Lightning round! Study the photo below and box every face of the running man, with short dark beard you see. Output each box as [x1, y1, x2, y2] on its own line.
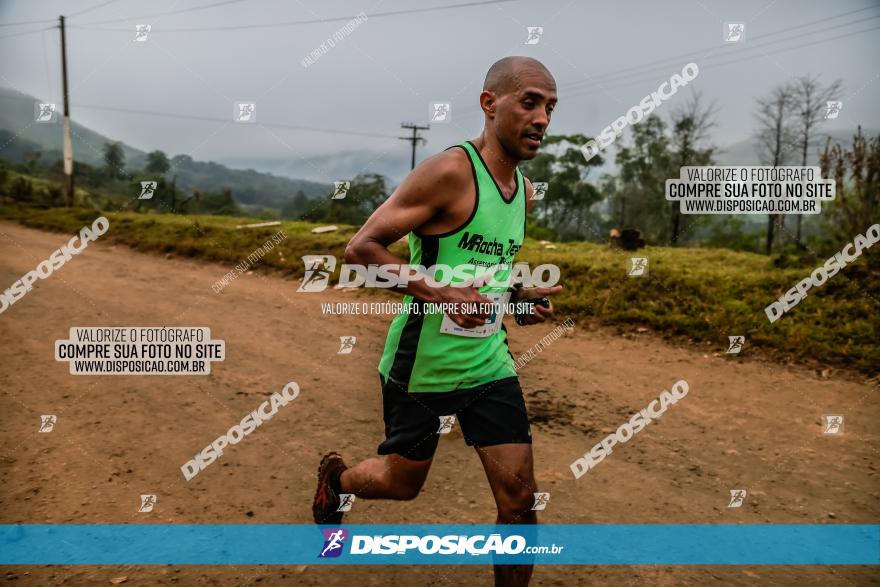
[494, 67, 556, 161]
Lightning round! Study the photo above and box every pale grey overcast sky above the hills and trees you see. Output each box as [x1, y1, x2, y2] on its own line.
[0, 0, 880, 183]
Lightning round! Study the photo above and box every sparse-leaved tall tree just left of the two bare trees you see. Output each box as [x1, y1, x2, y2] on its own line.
[664, 92, 717, 246]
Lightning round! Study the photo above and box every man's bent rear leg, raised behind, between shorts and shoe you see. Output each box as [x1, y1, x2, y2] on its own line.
[340, 454, 434, 500]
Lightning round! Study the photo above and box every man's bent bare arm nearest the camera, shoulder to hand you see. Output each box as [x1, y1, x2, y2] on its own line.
[345, 149, 488, 328]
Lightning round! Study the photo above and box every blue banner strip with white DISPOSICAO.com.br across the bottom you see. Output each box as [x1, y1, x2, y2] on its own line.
[0, 524, 880, 565]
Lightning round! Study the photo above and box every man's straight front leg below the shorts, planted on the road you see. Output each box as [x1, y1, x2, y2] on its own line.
[477, 444, 538, 587]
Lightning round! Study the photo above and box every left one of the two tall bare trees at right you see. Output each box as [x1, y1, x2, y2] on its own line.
[755, 84, 795, 255]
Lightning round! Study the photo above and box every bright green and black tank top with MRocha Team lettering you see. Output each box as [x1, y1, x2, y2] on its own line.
[379, 141, 526, 392]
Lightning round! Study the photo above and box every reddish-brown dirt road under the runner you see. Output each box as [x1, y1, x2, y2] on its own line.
[0, 222, 880, 586]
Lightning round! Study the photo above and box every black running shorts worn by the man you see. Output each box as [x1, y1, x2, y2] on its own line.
[378, 375, 532, 461]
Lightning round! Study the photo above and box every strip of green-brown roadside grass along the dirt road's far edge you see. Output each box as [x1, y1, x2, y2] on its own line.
[0, 206, 880, 374]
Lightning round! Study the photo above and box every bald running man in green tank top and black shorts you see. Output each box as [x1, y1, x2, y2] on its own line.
[312, 57, 562, 585]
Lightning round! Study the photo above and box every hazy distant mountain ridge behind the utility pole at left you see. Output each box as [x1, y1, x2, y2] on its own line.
[0, 88, 332, 210]
